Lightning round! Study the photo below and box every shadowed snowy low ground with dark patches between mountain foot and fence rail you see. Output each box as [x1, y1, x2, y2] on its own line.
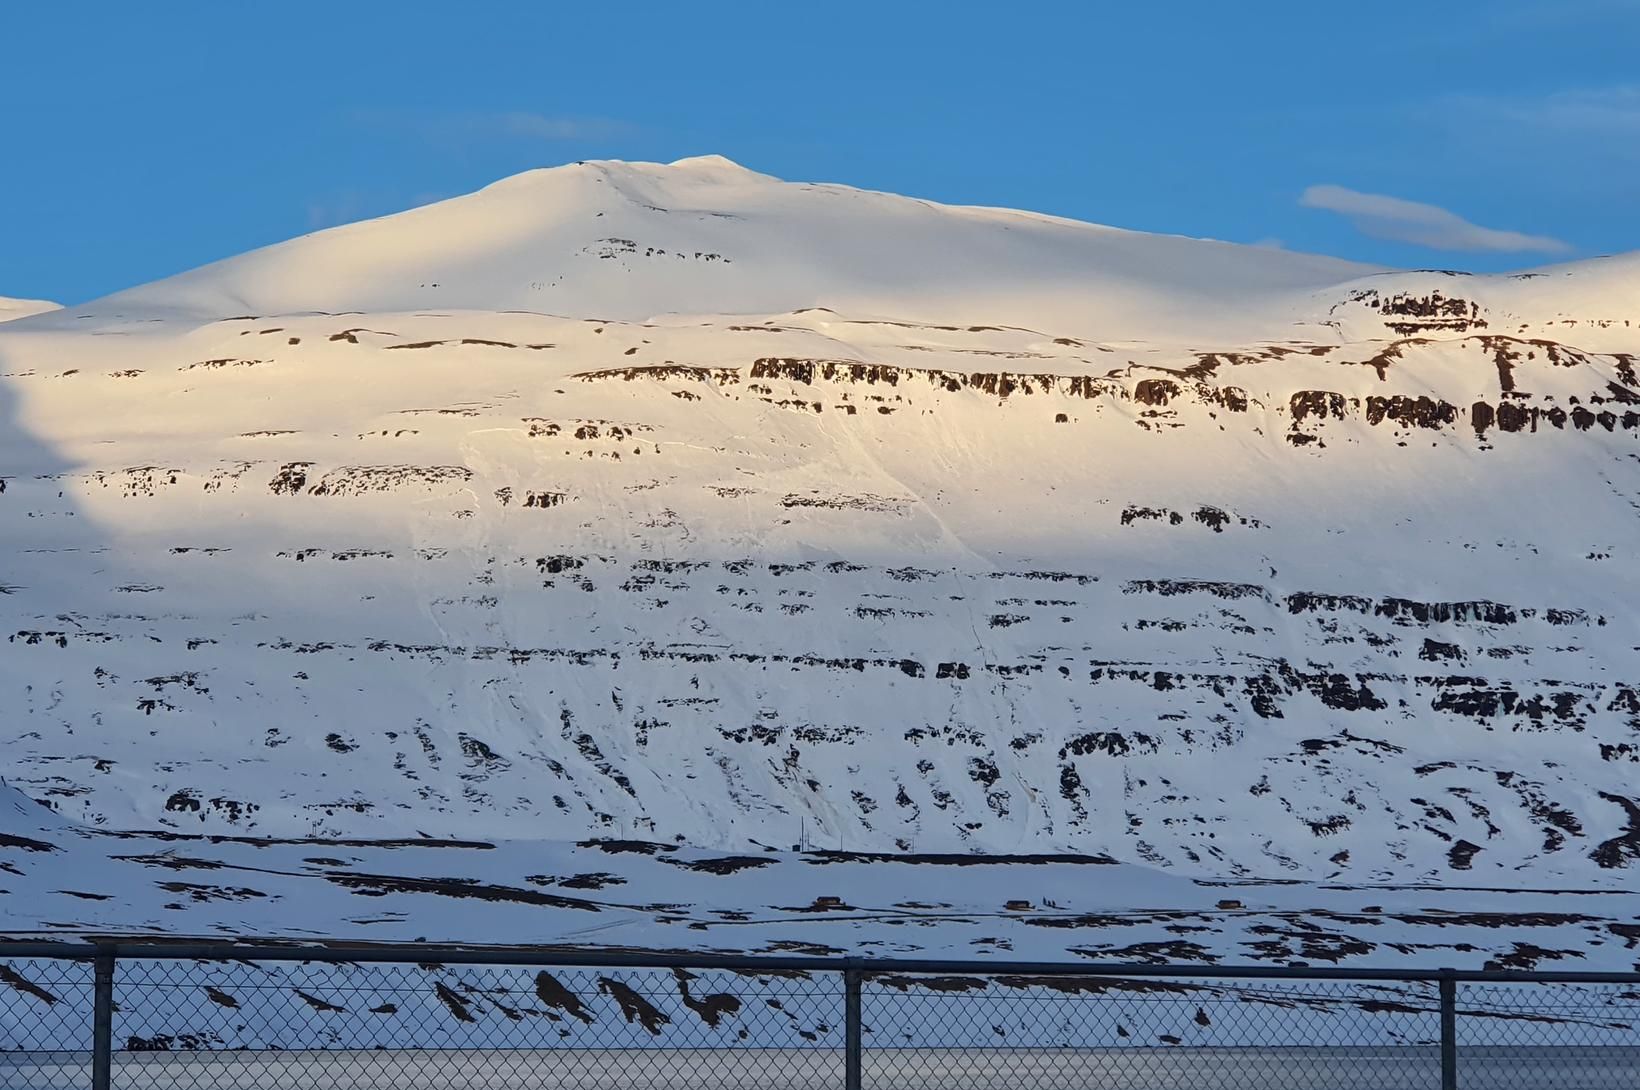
[0, 788, 1640, 970]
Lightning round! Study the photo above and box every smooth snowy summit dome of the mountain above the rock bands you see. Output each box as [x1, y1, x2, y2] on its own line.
[35, 156, 1374, 339]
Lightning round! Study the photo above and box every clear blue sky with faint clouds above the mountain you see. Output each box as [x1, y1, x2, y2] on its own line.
[0, 0, 1640, 302]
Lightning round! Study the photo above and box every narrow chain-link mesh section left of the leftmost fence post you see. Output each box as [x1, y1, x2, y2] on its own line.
[0, 959, 93, 1090]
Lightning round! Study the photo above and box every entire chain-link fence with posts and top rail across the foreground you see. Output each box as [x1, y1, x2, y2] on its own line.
[0, 942, 1640, 1090]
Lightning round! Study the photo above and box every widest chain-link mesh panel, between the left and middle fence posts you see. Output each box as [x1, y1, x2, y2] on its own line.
[113, 962, 843, 1090]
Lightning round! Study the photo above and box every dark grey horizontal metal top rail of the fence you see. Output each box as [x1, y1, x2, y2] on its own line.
[0, 938, 1640, 987]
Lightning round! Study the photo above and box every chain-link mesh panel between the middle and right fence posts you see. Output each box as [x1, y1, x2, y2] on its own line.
[861, 975, 1440, 1090]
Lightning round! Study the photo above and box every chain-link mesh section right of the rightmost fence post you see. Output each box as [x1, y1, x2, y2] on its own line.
[1458, 983, 1640, 1090]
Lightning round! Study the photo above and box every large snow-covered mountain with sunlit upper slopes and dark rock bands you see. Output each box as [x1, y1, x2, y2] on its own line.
[0, 157, 1640, 929]
